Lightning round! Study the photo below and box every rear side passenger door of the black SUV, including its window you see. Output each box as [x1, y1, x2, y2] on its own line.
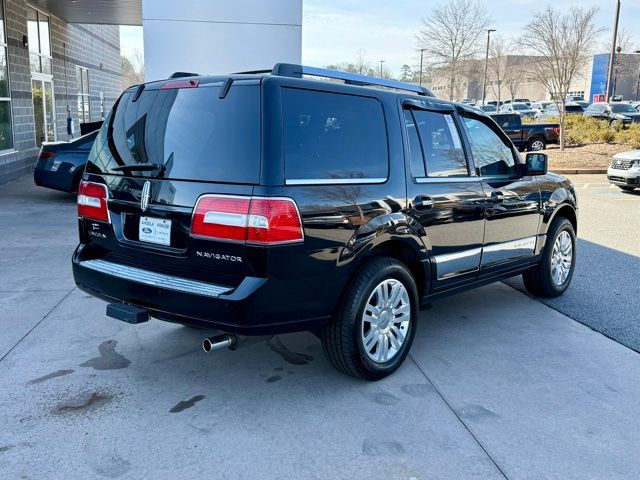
[403, 105, 484, 290]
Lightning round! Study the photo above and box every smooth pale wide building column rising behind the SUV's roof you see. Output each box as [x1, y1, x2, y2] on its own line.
[142, 0, 302, 81]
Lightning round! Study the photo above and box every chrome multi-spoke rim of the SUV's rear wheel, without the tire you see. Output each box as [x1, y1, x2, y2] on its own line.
[361, 278, 411, 363]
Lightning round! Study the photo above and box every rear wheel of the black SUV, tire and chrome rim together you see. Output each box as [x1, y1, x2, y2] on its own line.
[321, 257, 418, 380]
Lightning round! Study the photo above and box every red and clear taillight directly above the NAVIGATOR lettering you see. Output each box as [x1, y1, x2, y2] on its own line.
[191, 195, 304, 245]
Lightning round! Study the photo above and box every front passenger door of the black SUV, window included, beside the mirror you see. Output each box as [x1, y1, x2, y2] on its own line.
[463, 113, 541, 275]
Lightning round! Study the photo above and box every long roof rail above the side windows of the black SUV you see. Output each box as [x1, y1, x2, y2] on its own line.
[271, 63, 435, 97]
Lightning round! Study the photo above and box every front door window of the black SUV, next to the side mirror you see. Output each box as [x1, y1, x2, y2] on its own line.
[464, 117, 517, 176]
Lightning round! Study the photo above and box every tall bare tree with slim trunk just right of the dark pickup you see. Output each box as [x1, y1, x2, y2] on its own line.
[518, 6, 601, 150]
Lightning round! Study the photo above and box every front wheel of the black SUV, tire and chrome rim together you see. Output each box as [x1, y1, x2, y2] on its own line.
[522, 217, 576, 298]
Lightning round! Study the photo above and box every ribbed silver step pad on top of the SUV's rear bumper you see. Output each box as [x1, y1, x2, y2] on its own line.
[79, 260, 232, 298]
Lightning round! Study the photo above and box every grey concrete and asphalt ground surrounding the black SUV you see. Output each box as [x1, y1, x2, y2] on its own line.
[0, 175, 640, 479]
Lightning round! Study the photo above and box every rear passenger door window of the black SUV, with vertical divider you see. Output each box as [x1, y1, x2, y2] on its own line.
[413, 110, 469, 177]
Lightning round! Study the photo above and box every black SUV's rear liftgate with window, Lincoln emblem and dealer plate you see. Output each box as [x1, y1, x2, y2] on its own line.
[85, 80, 261, 286]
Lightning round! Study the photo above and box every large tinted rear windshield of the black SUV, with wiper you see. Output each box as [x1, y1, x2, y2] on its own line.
[87, 85, 260, 183]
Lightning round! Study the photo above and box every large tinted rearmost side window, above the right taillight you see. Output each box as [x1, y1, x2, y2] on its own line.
[282, 88, 389, 180]
